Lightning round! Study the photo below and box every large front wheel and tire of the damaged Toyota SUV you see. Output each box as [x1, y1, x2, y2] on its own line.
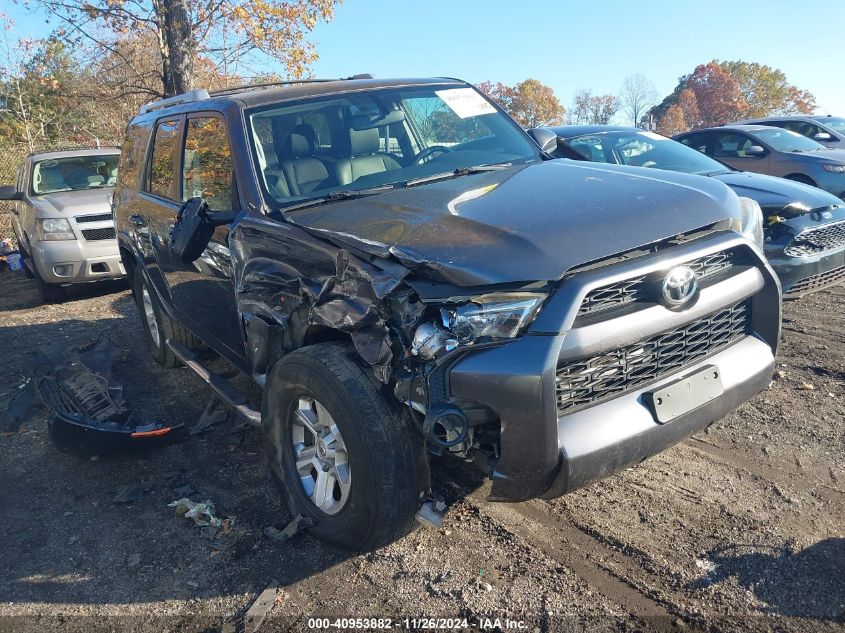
[262, 342, 427, 551]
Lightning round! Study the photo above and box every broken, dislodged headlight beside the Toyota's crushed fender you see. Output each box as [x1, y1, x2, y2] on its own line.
[411, 292, 546, 360]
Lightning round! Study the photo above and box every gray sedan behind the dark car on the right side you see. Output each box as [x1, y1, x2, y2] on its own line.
[673, 125, 845, 200]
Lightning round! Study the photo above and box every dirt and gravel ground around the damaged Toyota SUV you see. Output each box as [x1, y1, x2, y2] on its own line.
[0, 273, 845, 632]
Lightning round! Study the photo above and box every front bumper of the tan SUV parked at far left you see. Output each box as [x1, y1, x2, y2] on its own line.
[30, 240, 126, 284]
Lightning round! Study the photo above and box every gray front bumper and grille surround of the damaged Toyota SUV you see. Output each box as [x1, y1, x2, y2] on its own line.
[447, 236, 780, 501]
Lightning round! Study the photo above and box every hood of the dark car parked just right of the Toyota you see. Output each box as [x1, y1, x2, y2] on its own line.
[713, 170, 845, 217]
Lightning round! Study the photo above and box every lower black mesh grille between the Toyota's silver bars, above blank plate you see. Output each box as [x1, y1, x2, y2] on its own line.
[557, 301, 751, 415]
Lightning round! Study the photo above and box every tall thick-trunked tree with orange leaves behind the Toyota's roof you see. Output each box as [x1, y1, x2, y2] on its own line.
[32, 0, 338, 96]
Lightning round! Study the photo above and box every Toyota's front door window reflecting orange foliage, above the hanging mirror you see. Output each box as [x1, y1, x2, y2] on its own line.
[182, 117, 235, 211]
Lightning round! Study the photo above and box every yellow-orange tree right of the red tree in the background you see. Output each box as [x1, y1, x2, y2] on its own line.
[719, 61, 816, 118]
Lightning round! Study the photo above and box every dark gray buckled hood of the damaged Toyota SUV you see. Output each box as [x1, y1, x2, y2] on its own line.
[288, 160, 739, 286]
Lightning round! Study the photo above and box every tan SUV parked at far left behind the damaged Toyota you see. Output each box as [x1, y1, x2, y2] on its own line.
[0, 148, 126, 302]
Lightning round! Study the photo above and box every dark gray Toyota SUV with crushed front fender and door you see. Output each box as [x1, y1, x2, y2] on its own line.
[114, 76, 781, 550]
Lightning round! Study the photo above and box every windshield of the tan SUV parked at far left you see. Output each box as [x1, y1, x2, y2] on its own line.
[32, 154, 118, 195]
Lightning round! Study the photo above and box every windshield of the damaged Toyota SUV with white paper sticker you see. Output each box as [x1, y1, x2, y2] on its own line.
[248, 86, 540, 207]
